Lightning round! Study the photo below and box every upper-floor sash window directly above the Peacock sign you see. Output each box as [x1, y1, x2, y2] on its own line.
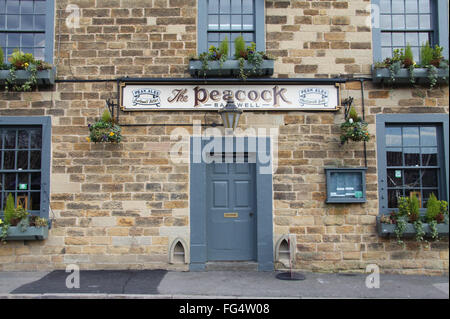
[198, 0, 265, 56]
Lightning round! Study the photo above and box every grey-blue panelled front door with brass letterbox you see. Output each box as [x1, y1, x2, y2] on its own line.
[206, 163, 256, 261]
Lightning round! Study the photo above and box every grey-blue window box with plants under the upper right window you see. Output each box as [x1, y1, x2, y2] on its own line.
[372, 43, 449, 88]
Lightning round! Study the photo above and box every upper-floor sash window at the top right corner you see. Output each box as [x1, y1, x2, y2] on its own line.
[372, 0, 448, 62]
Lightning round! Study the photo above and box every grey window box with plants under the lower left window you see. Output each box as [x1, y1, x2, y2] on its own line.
[0, 194, 49, 243]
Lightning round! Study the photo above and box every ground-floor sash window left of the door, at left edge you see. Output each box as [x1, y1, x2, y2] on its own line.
[0, 117, 51, 218]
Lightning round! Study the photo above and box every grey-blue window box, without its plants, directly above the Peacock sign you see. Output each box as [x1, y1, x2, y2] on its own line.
[189, 60, 274, 78]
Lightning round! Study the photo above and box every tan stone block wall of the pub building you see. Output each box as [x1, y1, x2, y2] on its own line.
[0, 0, 449, 274]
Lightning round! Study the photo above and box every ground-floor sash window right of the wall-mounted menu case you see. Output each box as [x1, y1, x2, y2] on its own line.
[377, 114, 448, 213]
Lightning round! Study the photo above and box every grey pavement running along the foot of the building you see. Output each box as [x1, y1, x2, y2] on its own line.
[0, 270, 449, 299]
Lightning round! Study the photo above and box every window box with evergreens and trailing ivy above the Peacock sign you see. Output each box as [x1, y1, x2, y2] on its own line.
[189, 36, 274, 80]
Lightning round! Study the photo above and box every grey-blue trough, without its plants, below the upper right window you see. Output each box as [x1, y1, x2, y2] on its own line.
[372, 67, 448, 84]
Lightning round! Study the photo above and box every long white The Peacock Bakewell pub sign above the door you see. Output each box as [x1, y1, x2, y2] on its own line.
[120, 81, 340, 111]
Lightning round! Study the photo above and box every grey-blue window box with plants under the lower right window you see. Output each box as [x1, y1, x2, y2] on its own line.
[377, 194, 448, 241]
